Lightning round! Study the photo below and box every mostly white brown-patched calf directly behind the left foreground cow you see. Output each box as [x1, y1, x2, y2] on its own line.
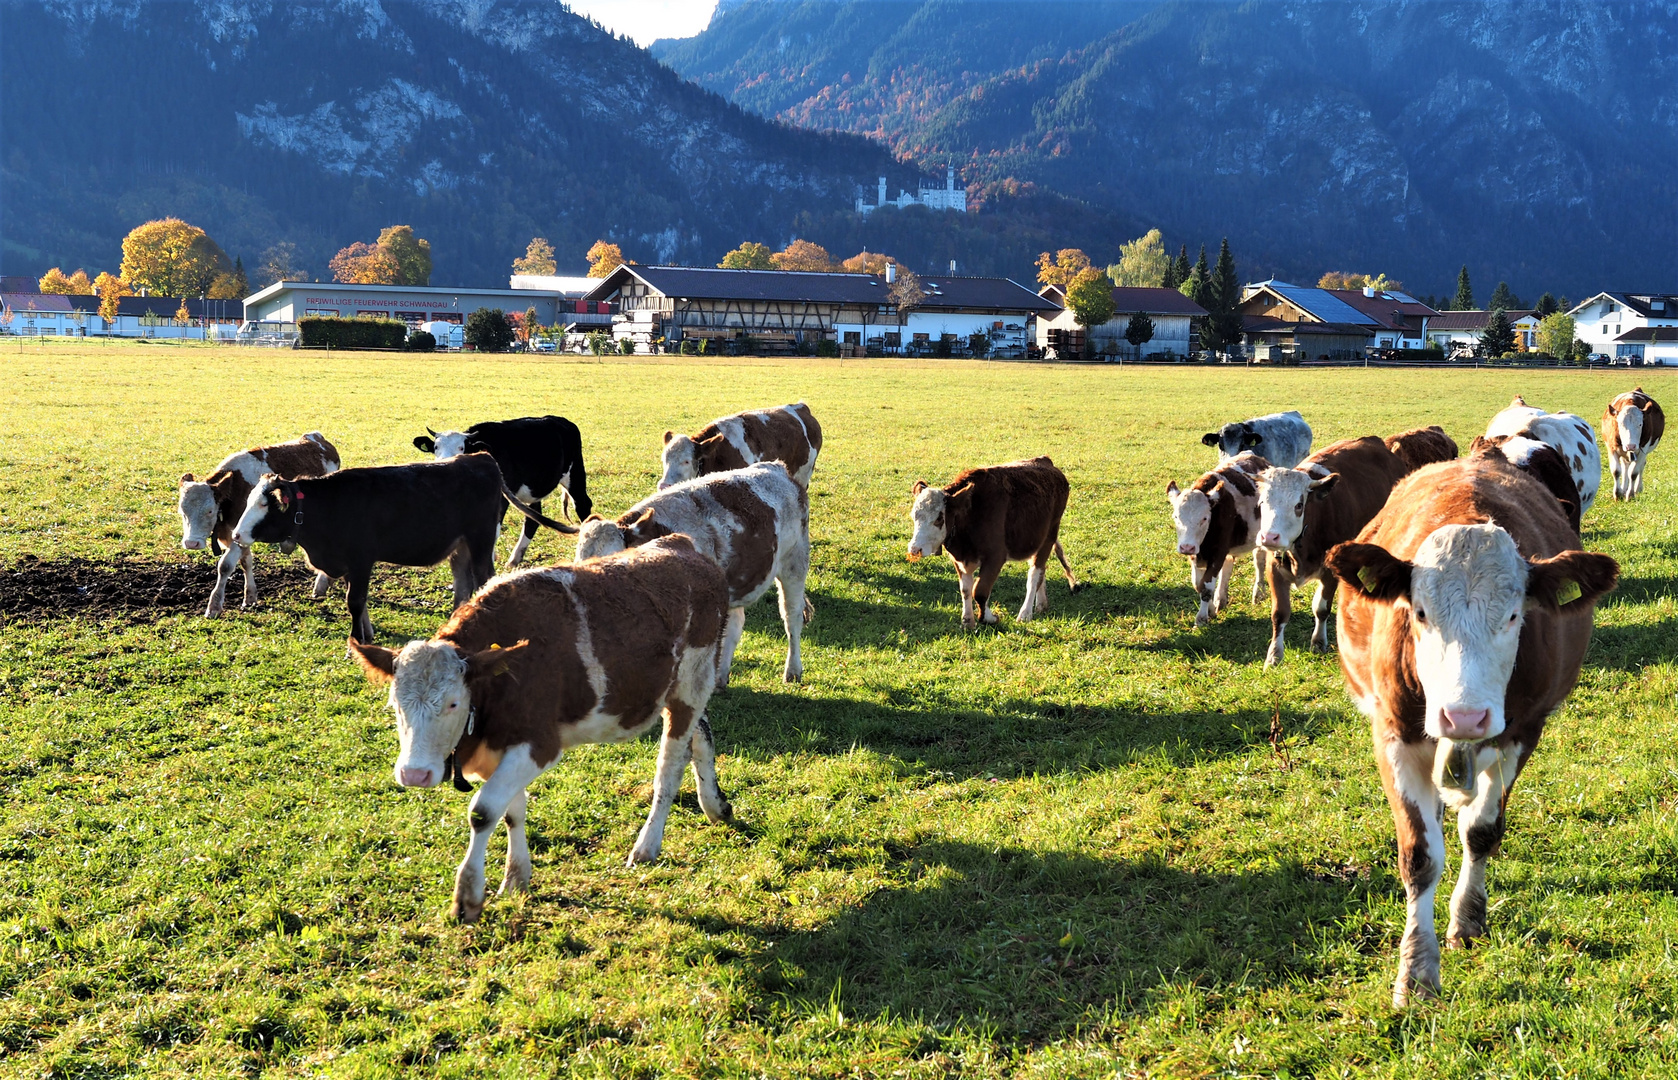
[577, 461, 810, 688]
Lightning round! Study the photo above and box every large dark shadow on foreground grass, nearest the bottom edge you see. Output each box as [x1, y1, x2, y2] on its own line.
[671, 840, 1375, 1041]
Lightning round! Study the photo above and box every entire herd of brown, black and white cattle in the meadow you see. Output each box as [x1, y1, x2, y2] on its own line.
[170, 387, 1665, 1003]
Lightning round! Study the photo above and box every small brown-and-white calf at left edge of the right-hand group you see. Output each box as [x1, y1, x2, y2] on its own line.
[1165, 453, 1270, 626]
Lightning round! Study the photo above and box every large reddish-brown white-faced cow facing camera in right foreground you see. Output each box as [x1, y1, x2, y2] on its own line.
[1329, 454, 1619, 1006]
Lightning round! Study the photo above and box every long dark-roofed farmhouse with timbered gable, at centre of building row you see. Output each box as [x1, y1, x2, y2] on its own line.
[586, 265, 1059, 357]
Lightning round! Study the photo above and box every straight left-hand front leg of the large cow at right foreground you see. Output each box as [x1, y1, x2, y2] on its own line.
[1382, 734, 1445, 1008]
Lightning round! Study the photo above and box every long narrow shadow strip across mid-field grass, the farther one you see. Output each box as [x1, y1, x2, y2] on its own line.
[710, 686, 1327, 778]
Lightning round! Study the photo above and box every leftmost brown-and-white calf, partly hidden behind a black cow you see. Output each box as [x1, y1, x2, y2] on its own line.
[178, 431, 342, 619]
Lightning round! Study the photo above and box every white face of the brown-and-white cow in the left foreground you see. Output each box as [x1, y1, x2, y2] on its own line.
[391, 641, 472, 788]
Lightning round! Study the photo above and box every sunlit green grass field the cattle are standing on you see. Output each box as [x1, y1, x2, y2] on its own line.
[0, 344, 1678, 1080]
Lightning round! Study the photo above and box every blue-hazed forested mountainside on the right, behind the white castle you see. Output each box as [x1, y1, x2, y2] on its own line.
[659, 0, 1678, 295]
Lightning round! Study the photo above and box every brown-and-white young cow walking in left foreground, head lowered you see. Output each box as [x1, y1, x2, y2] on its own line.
[349, 535, 733, 922]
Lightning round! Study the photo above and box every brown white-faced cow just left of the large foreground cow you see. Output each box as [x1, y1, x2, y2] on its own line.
[1257, 434, 1410, 667]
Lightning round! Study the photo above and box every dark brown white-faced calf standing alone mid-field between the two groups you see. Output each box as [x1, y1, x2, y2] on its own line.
[909, 458, 1077, 629]
